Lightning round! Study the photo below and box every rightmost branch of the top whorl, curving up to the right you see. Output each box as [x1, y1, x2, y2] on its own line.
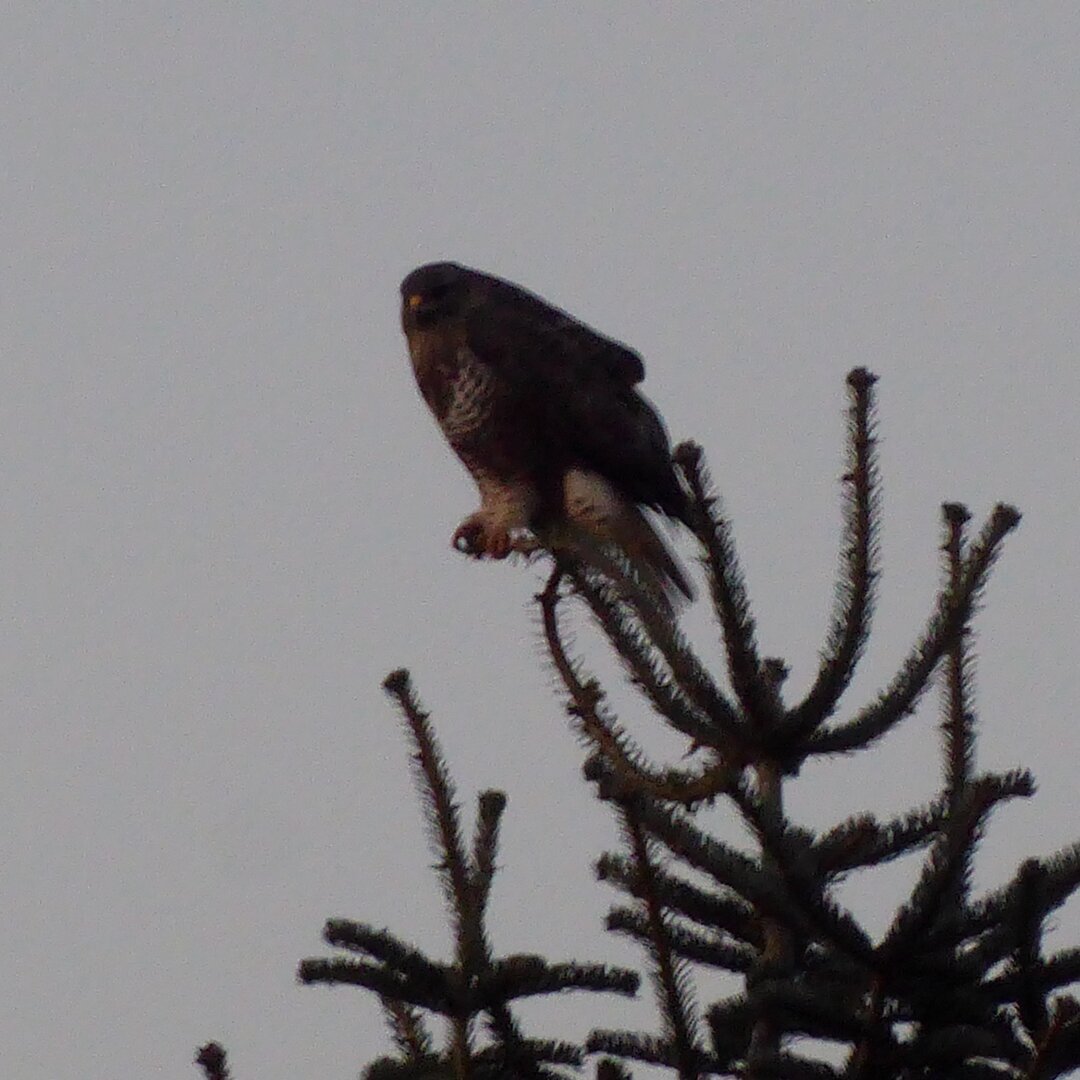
[806, 505, 1020, 754]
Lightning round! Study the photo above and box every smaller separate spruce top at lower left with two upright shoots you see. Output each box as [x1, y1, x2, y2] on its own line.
[299, 671, 639, 1080]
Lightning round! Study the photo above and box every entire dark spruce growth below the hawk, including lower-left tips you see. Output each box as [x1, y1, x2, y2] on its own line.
[200, 369, 1080, 1080]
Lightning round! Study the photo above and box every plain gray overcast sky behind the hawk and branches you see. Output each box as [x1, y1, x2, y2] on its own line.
[0, 0, 1080, 1080]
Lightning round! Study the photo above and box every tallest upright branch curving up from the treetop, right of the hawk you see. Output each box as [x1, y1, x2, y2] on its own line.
[782, 367, 880, 738]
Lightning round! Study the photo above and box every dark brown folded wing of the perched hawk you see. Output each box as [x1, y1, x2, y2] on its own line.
[469, 274, 686, 517]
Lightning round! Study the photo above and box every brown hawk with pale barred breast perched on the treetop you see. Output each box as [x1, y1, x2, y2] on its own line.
[402, 262, 691, 597]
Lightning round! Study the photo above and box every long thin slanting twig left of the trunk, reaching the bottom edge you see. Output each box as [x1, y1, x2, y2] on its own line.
[620, 799, 701, 1080]
